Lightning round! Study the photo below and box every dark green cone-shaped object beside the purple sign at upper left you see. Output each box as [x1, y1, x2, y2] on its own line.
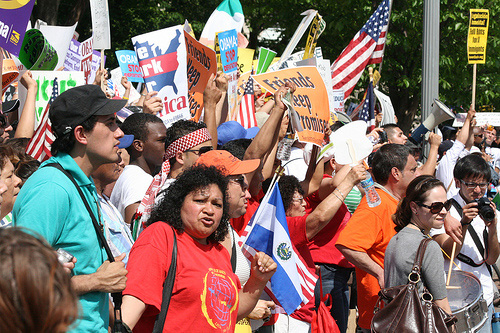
[19, 29, 58, 70]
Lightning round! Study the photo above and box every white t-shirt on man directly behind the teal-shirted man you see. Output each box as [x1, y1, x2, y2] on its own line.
[110, 165, 153, 218]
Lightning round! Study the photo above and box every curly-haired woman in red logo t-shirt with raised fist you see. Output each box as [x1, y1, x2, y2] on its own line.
[122, 166, 276, 332]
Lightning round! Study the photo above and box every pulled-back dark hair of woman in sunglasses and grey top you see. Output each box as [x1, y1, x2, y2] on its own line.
[392, 175, 446, 232]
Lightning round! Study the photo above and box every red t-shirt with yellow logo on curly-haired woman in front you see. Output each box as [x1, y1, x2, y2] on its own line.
[123, 222, 241, 332]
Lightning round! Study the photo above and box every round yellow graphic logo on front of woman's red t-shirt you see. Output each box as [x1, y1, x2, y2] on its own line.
[201, 268, 238, 332]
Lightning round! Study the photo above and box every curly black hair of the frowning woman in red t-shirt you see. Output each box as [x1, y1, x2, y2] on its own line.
[146, 165, 229, 242]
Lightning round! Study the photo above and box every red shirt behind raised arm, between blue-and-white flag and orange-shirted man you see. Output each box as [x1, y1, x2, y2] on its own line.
[305, 175, 354, 268]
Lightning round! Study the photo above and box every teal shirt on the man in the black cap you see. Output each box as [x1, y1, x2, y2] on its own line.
[12, 153, 109, 333]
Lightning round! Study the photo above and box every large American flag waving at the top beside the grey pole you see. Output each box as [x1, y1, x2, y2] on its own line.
[331, 0, 390, 99]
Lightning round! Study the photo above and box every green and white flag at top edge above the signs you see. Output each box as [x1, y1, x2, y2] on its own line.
[200, 0, 245, 49]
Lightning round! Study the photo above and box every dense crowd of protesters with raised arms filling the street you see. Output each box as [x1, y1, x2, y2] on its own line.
[0, 65, 500, 333]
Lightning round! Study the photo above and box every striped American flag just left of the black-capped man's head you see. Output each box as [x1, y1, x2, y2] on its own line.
[26, 78, 59, 162]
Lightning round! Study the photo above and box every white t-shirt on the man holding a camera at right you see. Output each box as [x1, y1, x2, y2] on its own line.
[430, 193, 500, 304]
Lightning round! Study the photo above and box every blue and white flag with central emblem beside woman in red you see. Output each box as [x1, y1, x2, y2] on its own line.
[240, 182, 317, 314]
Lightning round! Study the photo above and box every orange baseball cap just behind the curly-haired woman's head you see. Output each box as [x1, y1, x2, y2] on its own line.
[196, 150, 260, 176]
